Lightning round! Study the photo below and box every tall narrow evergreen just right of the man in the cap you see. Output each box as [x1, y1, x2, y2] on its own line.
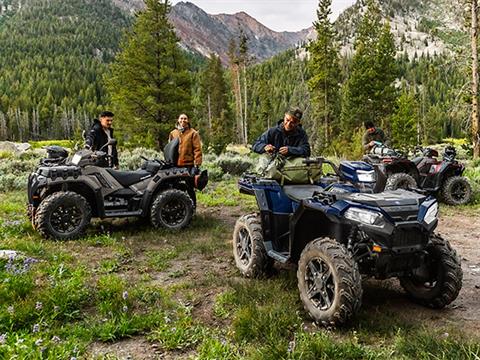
[308, 0, 341, 153]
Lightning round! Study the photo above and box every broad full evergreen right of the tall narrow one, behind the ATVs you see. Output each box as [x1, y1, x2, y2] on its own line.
[342, 0, 398, 137]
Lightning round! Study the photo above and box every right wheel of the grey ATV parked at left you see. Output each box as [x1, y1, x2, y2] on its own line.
[150, 189, 194, 230]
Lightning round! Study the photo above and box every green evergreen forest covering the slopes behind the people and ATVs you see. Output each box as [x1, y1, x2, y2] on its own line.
[0, 0, 476, 159]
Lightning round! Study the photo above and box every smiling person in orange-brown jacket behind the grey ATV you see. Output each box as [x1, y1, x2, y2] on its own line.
[168, 114, 202, 168]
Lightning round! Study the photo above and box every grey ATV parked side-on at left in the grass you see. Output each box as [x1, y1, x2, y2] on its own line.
[28, 140, 208, 239]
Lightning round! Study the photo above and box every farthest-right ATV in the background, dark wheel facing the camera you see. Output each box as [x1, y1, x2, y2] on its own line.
[412, 146, 472, 205]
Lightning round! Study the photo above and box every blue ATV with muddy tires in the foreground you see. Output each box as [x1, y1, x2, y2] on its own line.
[233, 159, 463, 326]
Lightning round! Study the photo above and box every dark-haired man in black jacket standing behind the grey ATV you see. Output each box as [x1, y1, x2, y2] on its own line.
[85, 111, 118, 168]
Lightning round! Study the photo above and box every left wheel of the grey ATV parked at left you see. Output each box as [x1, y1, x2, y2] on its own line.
[34, 191, 92, 240]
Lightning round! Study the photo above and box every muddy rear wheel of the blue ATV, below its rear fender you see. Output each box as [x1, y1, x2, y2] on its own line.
[233, 214, 273, 277]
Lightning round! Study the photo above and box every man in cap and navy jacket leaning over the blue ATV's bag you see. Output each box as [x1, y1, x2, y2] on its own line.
[252, 109, 310, 157]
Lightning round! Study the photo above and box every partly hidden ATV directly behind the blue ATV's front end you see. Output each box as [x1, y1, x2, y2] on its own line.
[363, 143, 420, 192]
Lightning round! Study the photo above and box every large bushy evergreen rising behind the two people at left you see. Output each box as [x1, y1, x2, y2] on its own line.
[107, 0, 191, 146]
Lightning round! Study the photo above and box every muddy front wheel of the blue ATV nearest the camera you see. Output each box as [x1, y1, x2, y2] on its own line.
[297, 238, 362, 326]
